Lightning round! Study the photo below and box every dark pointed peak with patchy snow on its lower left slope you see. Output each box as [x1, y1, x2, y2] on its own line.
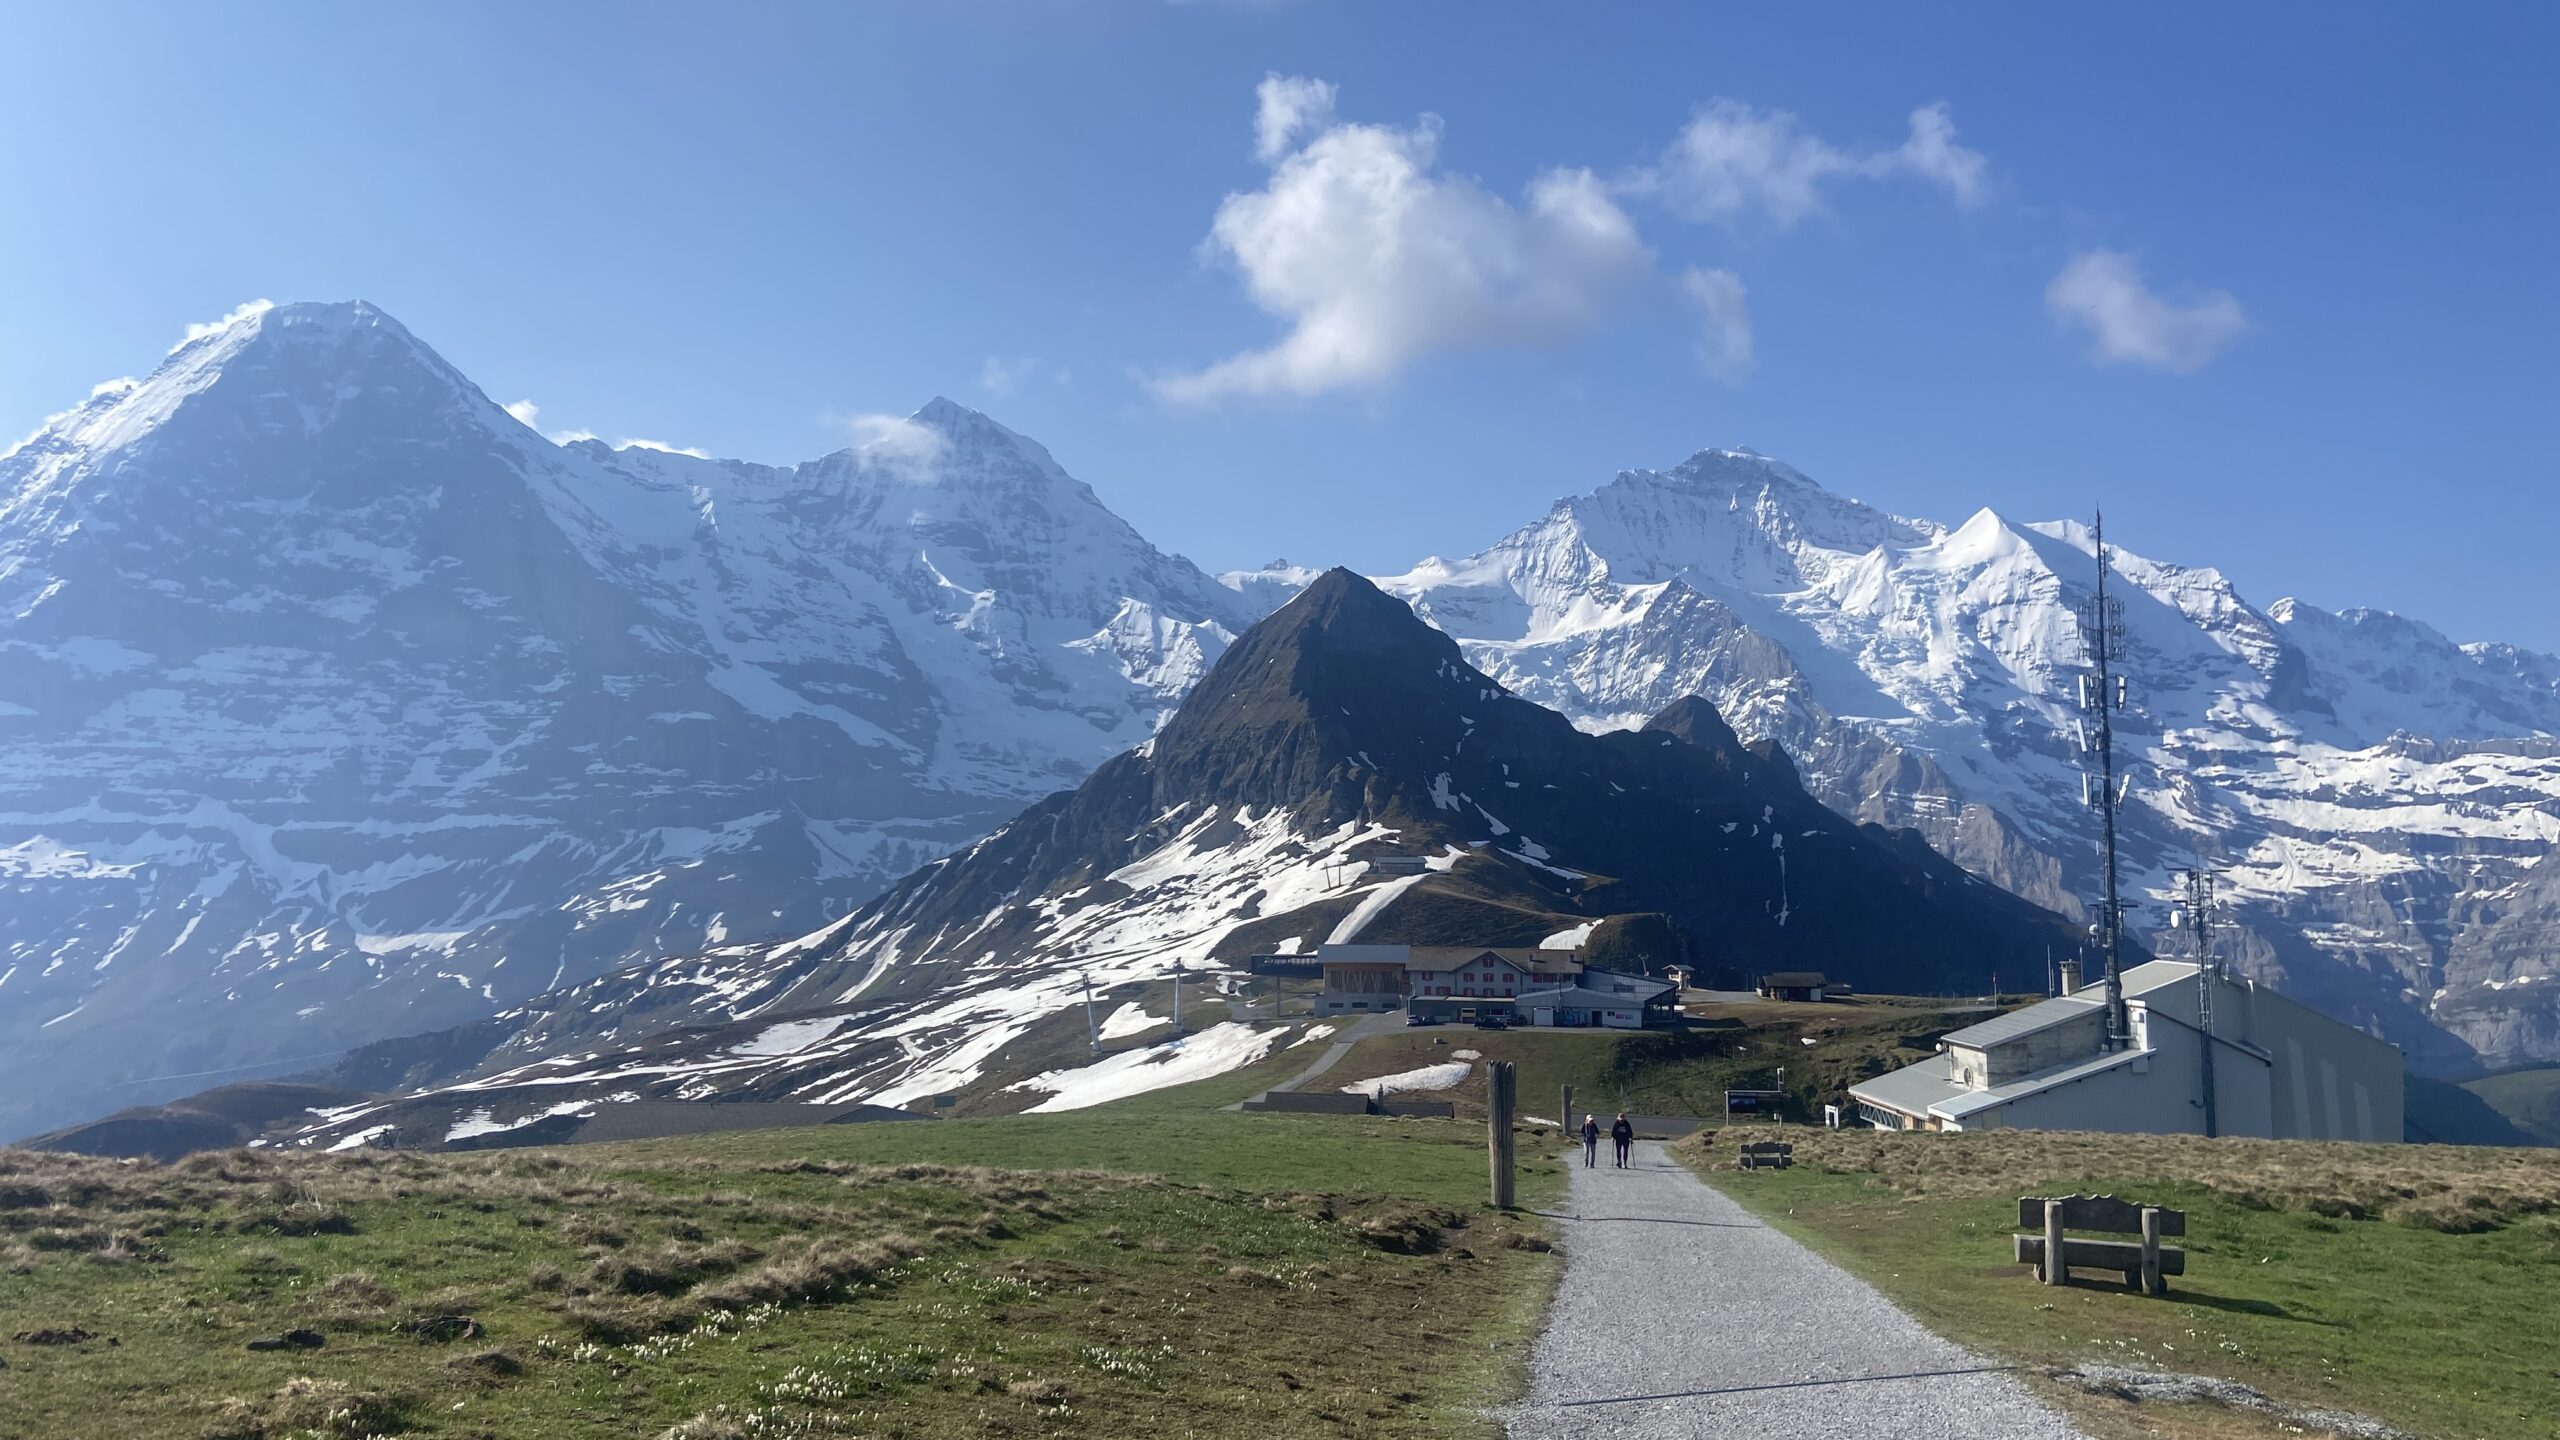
[280, 571, 2074, 1145]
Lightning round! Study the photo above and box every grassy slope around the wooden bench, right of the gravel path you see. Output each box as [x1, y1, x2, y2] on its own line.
[1682, 1130, 2560, 1440]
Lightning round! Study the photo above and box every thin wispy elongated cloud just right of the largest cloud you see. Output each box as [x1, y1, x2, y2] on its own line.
[1623, 100, 1989, 228]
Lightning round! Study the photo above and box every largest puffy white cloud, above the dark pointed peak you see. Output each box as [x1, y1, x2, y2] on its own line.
[1155, 77, 1651, 402]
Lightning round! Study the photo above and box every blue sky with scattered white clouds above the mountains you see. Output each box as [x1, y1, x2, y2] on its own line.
[0, 3, 2560, 648]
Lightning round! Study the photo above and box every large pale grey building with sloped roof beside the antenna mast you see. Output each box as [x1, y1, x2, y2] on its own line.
[1848, 961, 2401, 1140]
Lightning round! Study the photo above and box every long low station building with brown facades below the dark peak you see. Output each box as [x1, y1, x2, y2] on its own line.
[1316, 943, 1679, 1030]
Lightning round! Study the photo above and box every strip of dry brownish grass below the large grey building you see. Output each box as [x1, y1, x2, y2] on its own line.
[1682, 1127, 2560, 1235]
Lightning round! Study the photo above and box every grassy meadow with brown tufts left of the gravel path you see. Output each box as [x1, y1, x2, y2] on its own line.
[0, 1076, 1556, 1440]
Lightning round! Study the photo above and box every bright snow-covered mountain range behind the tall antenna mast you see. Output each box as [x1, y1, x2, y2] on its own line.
[1226, 451, 2560, 1071]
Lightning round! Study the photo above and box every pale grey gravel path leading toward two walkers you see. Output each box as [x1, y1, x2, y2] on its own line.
[1505, 1140, 2084, 1440]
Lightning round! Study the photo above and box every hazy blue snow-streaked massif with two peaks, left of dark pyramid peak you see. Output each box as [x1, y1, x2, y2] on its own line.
[0, 302, 1247, 1138]
